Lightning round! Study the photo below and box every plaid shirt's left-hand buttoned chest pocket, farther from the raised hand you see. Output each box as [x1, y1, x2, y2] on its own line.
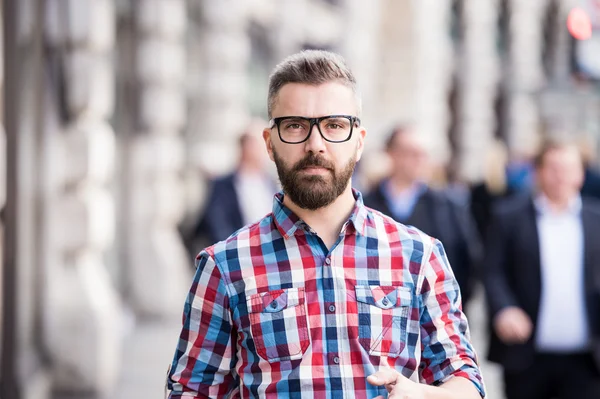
[247, 287, 310, 363]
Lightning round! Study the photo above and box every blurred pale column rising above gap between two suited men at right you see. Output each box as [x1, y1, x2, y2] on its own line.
[457, 0, 500, 181]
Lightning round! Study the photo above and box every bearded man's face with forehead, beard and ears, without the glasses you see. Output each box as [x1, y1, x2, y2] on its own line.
[263, 82, 366, 210]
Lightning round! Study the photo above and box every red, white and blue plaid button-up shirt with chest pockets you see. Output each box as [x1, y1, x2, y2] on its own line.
[168, 191, 485, 399]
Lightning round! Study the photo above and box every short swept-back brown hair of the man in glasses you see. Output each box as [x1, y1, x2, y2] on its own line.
[267, 50, 361, 118]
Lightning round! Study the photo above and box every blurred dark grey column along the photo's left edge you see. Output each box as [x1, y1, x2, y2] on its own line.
[0, 0, 50, 399]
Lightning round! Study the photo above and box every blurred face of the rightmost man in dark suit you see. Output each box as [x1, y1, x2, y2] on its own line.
[537, 147, 583, 201]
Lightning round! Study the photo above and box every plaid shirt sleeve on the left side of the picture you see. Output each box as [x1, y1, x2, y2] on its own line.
[167, 252, 237, 399]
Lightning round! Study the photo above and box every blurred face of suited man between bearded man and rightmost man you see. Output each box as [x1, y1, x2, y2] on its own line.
[388, 132, 430, 182]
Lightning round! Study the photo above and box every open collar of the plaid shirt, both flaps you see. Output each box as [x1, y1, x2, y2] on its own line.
[273, 189, 368, 238]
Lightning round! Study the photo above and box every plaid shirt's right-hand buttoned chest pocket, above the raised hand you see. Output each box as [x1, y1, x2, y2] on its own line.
[355, 285, 412, 357]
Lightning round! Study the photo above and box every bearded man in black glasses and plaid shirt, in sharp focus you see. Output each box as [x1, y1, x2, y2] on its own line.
[168, 51, 484, 399]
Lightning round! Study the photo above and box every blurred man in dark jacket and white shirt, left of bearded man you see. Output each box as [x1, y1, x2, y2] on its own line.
[193, 122, 277, 245]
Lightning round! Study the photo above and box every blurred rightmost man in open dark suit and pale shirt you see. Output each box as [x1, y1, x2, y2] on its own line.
[485, 143, 600, 399]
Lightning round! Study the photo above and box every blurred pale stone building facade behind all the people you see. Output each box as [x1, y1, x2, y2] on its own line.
[0, 0, 600, 399]
